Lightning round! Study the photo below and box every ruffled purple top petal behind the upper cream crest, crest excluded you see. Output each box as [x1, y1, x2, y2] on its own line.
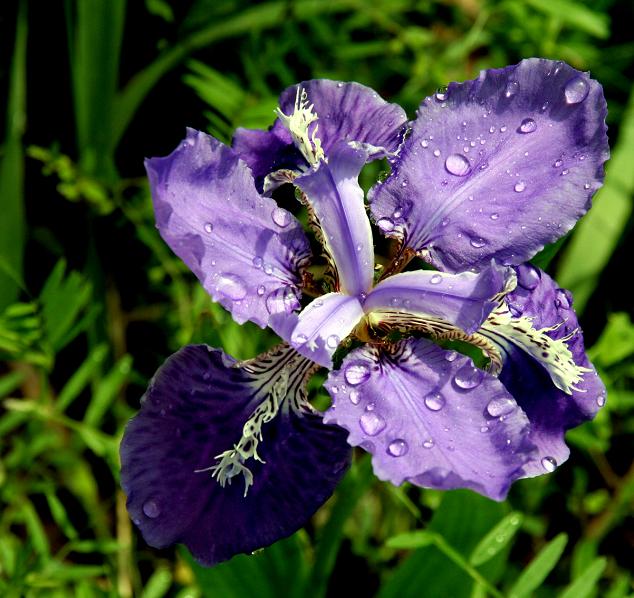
[233, 79, 407, 189]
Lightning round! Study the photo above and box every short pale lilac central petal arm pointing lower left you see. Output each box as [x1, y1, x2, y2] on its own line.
[270, 293, 363, 368]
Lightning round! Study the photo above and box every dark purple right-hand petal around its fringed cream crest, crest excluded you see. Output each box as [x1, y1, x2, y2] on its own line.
[492, 265, 606, 477]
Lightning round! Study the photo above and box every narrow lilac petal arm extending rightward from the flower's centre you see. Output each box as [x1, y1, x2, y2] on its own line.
[363, 263, 512, 334]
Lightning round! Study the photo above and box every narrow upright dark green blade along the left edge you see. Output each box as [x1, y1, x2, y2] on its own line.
[0, 0, 27, 312]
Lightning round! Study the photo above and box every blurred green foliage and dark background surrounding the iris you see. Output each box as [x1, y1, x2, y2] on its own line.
[0, 0, 634, 598]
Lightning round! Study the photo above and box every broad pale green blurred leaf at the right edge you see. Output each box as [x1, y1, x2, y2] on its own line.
[549, 86, 634, 313]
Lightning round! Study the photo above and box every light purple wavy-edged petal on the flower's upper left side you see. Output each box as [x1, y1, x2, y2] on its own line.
[146, 129, 310, 327]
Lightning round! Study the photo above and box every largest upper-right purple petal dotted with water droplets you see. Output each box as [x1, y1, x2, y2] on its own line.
[369, 58, 609, 271]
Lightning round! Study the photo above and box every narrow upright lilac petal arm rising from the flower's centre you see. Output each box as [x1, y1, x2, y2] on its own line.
[295, 143, 374, 295]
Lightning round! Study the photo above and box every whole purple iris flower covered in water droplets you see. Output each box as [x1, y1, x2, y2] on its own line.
[121, 59, 608, 565]
